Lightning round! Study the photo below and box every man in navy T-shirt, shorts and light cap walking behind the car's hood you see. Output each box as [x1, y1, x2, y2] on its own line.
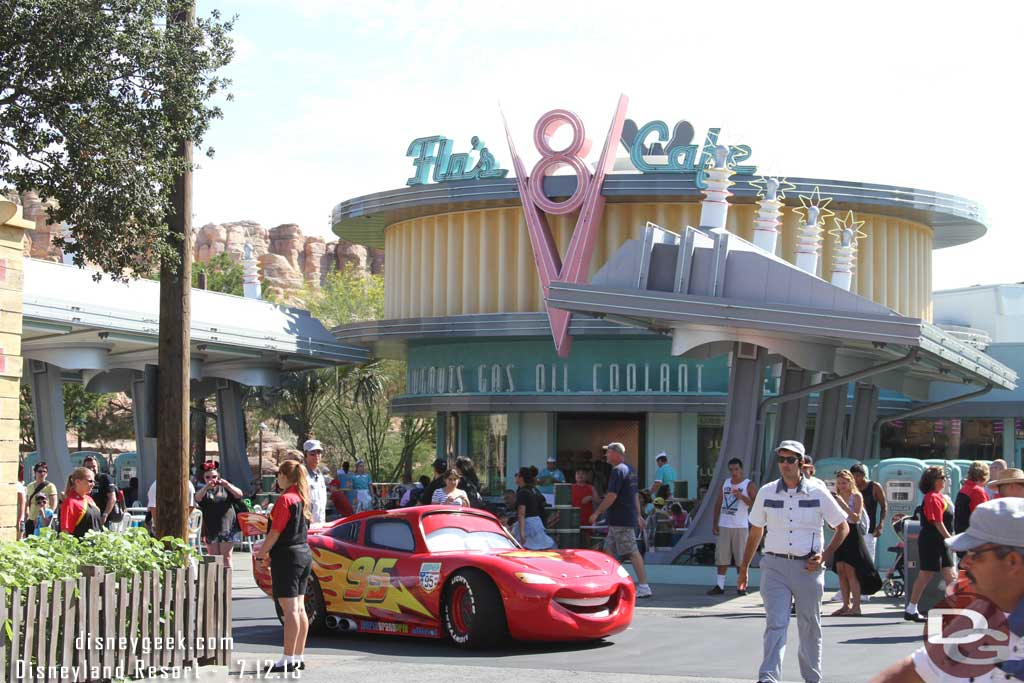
[590, 441, 651, 598]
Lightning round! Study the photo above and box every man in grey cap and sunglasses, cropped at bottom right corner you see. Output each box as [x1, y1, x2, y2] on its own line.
[872, 498, 1024, 683]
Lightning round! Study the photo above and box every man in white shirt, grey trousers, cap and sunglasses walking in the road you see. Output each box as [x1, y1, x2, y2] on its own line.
[736, 441, 850, 683]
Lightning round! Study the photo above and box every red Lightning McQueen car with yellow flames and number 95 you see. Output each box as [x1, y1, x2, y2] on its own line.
[253, 506, 636, 647]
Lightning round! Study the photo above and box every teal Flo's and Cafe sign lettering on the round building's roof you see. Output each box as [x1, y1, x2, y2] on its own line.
[406, 119, 757, 189]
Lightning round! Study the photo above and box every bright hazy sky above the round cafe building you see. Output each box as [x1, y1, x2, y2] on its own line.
[194, 0, 1024, 290]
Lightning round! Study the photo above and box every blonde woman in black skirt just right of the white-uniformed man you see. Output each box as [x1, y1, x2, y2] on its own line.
[833, 470, 882, 616]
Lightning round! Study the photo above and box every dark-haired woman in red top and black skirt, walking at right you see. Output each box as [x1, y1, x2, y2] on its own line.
[903, 467, 956, 622]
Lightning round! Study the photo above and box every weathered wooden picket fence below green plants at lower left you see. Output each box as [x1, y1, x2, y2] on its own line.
[0, 557, 231, 681]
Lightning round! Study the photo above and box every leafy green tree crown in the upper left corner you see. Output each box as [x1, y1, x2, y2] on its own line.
[0, 0, 233, 278]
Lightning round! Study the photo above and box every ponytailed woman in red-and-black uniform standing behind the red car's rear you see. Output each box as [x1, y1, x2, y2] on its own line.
[256, 460, 312, 673]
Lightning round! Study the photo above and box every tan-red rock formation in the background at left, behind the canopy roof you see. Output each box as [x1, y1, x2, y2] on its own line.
[19, 193, 384, 301]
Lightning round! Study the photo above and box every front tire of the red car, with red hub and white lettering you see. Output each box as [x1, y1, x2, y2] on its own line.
[441, 569, 508, 649]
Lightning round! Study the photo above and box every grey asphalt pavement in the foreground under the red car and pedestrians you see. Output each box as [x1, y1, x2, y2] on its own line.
[227, 553, 923, 683]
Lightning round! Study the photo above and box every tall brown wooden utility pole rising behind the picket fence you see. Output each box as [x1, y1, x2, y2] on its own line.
[154, 0, 196, 539]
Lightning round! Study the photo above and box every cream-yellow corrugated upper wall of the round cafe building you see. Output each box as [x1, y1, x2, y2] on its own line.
[384, 203, 932, 321]
